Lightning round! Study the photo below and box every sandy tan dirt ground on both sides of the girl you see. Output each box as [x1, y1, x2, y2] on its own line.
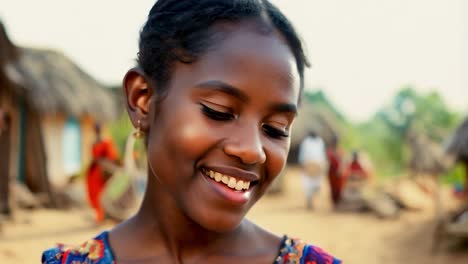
[0, 168, 468, 264]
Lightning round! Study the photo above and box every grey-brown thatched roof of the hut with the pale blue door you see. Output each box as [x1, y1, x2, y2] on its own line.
[7, 48, 117, 121]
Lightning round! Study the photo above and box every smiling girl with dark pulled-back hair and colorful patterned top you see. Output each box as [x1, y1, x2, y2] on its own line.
[42, 0, 340, 264]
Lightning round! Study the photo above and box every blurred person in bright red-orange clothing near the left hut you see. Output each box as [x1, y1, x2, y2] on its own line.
[86, 124, 119, 223]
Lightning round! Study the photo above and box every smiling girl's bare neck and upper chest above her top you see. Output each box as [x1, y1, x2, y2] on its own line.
[110, 175, 281, 263]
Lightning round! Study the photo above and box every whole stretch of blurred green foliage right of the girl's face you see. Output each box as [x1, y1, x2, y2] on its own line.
[305, 87, 461, 178]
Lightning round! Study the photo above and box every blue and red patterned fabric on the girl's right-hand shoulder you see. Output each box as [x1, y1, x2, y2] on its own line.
[274, 236, 341, 264]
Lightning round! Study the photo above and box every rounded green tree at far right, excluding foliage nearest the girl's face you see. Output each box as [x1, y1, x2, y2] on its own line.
[359, 87, 460, 177]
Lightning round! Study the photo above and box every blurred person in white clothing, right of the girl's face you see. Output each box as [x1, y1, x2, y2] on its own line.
[299, 131, 327, 209]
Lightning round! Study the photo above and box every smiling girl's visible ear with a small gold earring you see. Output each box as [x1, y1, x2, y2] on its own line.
[123, 68, 153, 131]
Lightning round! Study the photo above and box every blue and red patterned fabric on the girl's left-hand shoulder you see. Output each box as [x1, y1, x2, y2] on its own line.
[42, 231, 115, 264]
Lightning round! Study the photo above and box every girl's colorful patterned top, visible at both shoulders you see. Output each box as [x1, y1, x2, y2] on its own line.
[42, 231, 341, 264]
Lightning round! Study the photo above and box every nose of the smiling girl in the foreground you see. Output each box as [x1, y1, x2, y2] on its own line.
[224, 126, 266, 165]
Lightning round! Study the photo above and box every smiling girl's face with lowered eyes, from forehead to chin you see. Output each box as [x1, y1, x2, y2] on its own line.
[143, 24, 300, 232]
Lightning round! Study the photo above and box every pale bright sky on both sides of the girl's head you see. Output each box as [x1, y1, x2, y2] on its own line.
[0, 0, 468, 120]
